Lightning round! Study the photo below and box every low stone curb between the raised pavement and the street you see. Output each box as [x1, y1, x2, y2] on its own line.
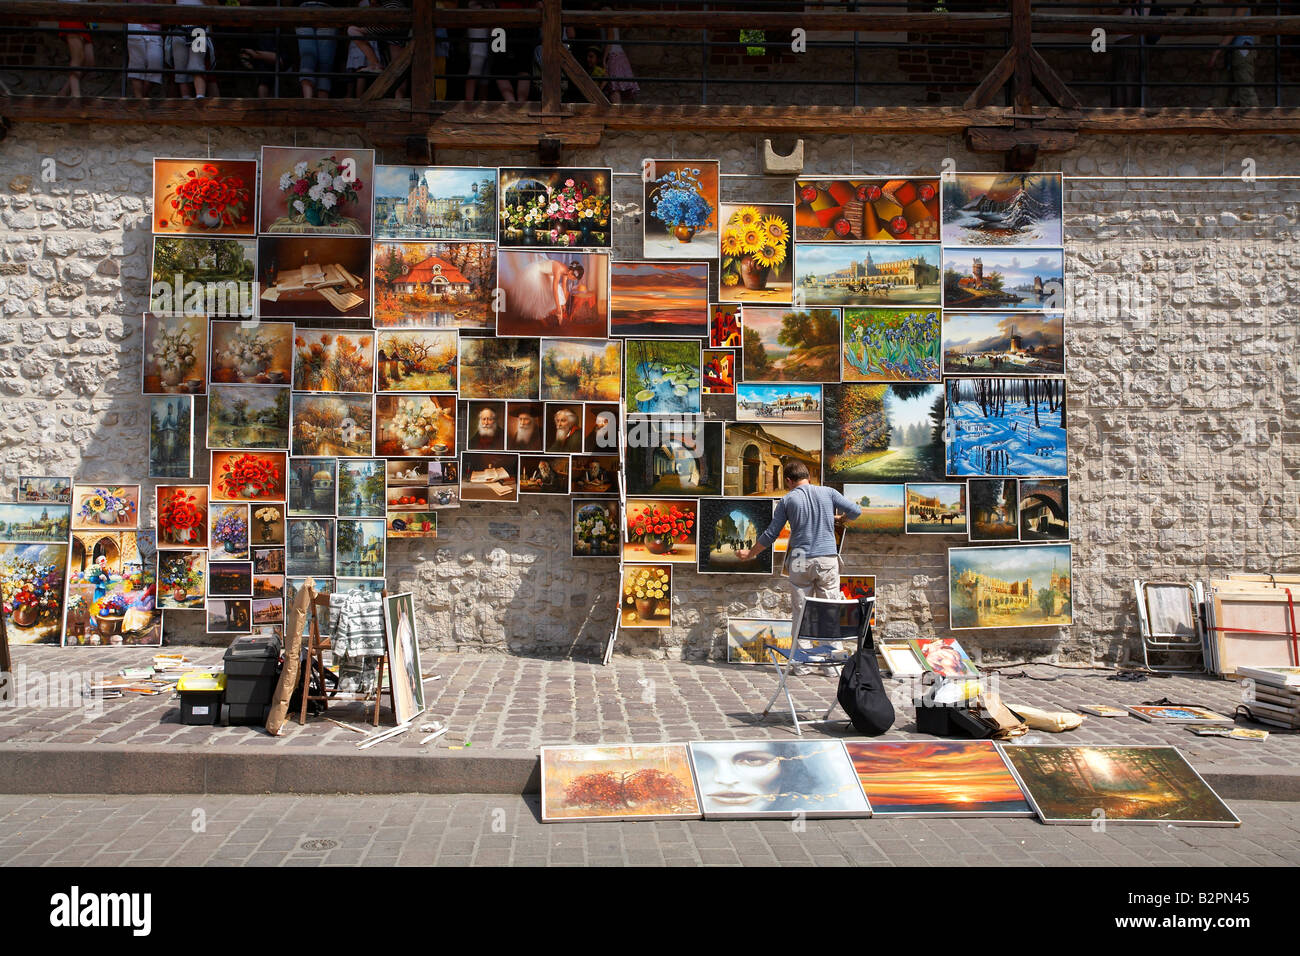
[0, 744, 1300, 803]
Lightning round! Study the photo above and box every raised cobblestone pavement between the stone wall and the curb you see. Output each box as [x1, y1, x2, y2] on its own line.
[0, 646, 1300, 770]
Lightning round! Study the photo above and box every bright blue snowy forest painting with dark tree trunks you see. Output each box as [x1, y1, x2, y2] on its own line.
[945, 378, 1066, 477]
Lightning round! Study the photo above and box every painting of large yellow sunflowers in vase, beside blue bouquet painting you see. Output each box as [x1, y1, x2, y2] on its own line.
[718, 203, 794, 303]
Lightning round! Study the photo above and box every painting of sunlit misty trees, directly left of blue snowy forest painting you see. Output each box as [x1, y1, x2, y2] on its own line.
[823, 382, 944, 483]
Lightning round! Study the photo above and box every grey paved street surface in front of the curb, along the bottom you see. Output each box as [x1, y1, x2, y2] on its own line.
[0, 795, 1300, 866]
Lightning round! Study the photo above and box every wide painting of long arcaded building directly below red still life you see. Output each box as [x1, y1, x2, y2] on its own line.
[794, 242, 943, 306]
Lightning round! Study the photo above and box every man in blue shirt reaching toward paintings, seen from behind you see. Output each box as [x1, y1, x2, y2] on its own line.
[737, 460, 862, 635]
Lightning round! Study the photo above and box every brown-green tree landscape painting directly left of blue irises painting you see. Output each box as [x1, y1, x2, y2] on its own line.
[742, 306, 840, 382]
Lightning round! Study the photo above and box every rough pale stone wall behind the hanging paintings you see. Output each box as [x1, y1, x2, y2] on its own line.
[0, 125, 1300, 659]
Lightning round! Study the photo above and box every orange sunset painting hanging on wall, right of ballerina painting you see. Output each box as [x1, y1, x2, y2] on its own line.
[610, 261, 710, 338]
